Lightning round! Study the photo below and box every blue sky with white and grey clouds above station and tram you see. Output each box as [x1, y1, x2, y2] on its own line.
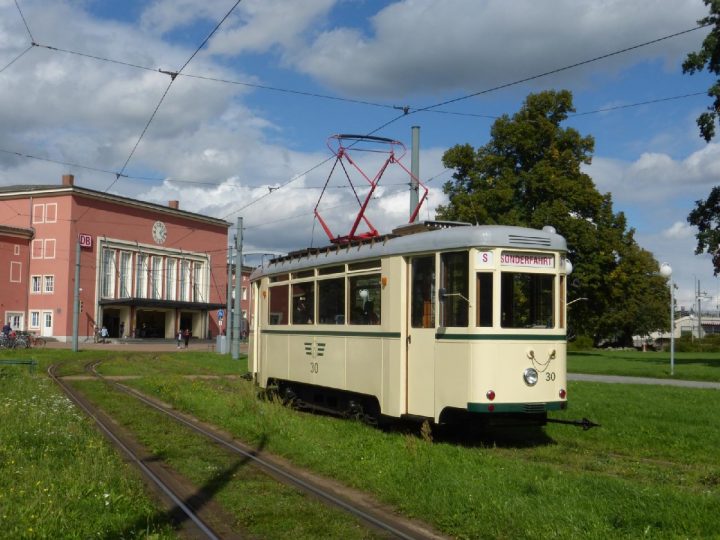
[0, 0, 720, 309]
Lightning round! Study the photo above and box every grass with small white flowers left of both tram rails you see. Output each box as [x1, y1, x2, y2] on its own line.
[0, 367, 175, 538]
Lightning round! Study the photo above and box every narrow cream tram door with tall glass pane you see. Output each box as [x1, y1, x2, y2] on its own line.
[407, 255, 436, 416]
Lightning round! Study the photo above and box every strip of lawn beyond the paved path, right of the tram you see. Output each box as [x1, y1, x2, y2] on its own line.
[568, 350, 720, 382]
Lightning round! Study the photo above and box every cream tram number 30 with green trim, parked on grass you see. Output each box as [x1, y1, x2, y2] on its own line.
[249, 221, 571, 423]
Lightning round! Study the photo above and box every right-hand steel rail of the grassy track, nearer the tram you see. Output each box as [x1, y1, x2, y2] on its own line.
[86, 361, 428, 540]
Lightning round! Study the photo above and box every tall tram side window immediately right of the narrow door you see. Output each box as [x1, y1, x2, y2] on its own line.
[440, 251, 470, 327]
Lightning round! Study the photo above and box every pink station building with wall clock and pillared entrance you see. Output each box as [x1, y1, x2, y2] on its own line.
[0, 175, 230, 341]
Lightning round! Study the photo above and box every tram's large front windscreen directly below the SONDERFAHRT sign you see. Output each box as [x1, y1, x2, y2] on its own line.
[500, 272, 555, 328]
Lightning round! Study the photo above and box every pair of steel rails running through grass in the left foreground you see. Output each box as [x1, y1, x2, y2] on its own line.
[48, 361, 442, 539]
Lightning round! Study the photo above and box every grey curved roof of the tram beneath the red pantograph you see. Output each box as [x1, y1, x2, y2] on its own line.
[250, 225, 567, 280]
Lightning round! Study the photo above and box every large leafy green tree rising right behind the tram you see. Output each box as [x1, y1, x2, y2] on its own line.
[438, 91, 669, 344]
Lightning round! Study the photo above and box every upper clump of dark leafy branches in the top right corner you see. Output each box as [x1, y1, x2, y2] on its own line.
[682, 0, 720, 142]
